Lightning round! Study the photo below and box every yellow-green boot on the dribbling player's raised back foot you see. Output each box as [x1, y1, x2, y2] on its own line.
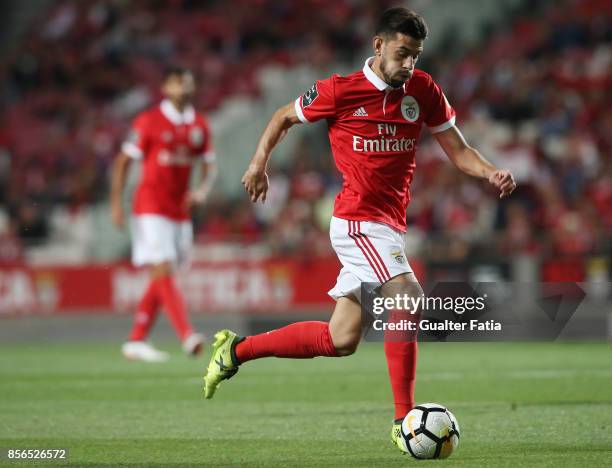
[204, 330, 243, 399]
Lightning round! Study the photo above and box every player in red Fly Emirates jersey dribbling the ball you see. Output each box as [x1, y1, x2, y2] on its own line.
[204, 8, 515, 454]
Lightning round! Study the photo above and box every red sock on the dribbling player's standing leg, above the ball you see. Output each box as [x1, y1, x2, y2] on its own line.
[385, 312, 418, 419]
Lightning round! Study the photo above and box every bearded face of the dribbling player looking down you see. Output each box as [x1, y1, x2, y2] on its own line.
[374, 33, 423, 88]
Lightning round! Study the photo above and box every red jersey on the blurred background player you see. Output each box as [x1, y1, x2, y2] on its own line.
[121, 100, 215, 221]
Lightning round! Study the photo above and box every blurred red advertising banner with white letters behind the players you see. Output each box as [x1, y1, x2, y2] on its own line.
[0, 257, 422, 316]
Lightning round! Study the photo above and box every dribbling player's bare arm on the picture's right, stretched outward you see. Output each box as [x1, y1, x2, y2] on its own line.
[434, 125, 516, 198]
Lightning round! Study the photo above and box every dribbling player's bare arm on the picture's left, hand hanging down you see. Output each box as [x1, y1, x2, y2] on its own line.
[242, 102, 301, 203]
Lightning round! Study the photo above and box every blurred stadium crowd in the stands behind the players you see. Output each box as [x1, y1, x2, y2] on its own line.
[0, 0, 612, 260]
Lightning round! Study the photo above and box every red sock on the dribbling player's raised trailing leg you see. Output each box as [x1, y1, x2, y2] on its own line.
[236, 322, 338, 363]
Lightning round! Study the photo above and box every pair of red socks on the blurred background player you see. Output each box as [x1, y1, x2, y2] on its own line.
[130, 276, 193, 341]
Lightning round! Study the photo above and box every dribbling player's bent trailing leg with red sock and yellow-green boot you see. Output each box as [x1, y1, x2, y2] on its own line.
[204, 296, 361, 398]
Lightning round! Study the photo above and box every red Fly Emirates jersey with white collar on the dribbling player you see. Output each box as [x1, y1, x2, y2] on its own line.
[295, 58, 455, 231]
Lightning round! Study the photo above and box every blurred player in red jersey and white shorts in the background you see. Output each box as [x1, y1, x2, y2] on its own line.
[111, 67, 216, 362]
